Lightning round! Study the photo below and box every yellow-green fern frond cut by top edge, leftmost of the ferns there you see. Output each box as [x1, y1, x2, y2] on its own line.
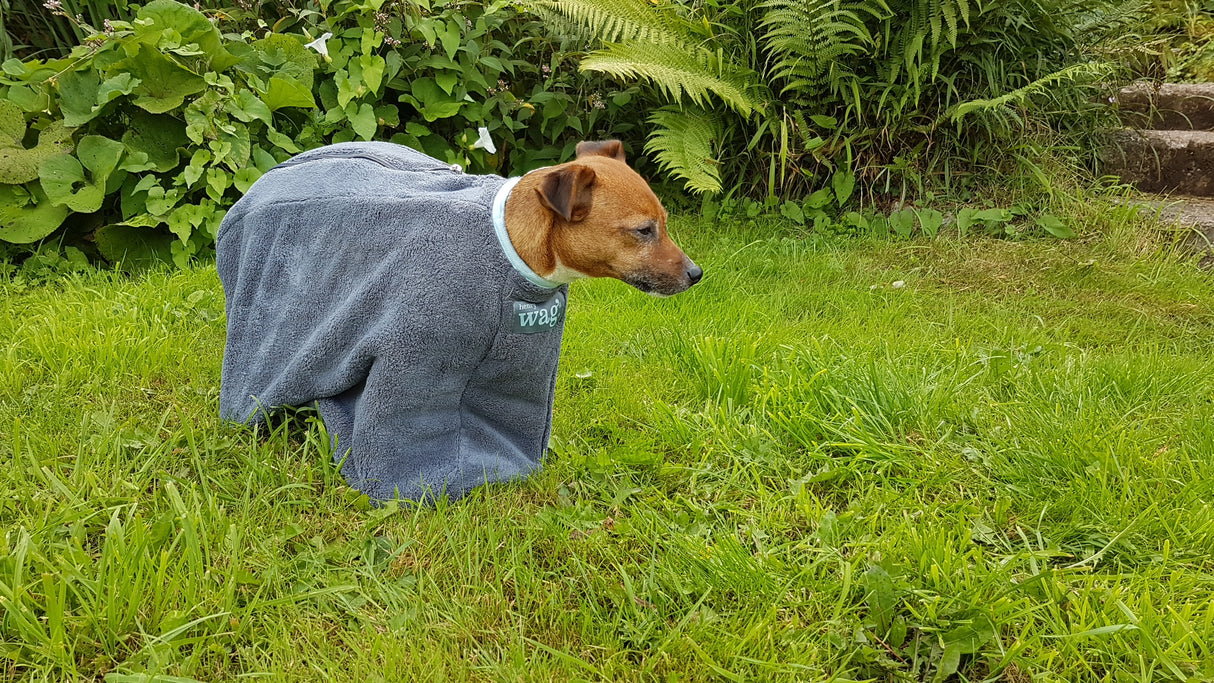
[535, 0, 683, 44]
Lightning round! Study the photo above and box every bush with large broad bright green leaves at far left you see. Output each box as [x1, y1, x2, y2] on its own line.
[0, 0, 314, 263]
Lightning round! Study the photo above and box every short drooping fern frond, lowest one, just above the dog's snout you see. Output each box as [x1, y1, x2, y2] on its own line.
[645, 107, 721, 194]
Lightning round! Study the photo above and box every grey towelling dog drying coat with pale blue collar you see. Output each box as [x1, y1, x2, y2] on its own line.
[216, 142, 568, 500]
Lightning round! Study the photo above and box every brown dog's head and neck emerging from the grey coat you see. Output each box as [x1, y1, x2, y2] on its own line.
[506, 140, 704, 296]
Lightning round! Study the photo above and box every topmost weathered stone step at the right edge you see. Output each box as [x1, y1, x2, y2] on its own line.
[1117, 82, 1214, 131]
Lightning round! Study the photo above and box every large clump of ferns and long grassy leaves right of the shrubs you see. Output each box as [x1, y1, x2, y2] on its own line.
[541, 0, 1127, 197]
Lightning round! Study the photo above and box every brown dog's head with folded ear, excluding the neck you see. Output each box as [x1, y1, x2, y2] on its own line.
[535, 140, 704, 296]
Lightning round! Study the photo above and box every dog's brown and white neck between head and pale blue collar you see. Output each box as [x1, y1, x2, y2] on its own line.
[506, 169, 586, 285]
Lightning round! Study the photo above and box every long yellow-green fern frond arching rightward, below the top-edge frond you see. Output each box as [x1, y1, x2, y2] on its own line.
[580, 41, 762, 116]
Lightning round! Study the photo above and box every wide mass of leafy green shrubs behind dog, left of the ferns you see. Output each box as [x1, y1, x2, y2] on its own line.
[0, 0, 637, 264]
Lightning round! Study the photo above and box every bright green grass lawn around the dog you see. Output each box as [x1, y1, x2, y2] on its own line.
[0, 206, 1214, 683]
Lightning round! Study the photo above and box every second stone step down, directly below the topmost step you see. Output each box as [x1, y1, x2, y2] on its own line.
[1101, 129, 1214, 197]
